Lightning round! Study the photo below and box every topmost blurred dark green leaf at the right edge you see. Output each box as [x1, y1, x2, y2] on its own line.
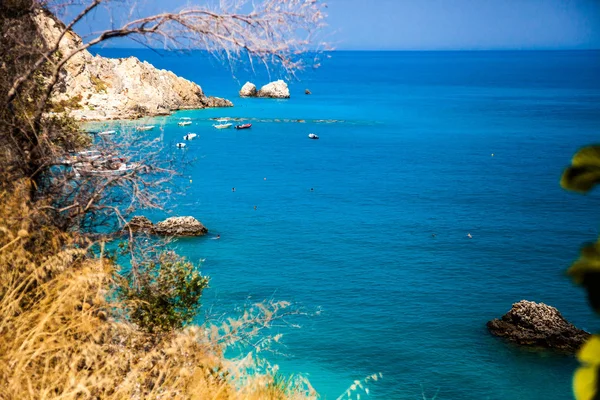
[560, 145, 600, 193]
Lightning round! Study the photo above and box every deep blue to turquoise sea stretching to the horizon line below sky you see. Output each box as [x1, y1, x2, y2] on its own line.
[92, 49, 600, 400]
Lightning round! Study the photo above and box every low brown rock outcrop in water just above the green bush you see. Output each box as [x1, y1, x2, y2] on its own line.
[123, 216, 208, 236]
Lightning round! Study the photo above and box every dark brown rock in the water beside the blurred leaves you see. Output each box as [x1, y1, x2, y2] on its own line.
[487, 300, 590, 353]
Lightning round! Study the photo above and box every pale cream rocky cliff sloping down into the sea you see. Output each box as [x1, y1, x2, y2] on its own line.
[35, 12, 233, 120]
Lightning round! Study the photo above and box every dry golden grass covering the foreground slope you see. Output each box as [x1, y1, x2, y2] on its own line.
[0, 185, 314, 400]
